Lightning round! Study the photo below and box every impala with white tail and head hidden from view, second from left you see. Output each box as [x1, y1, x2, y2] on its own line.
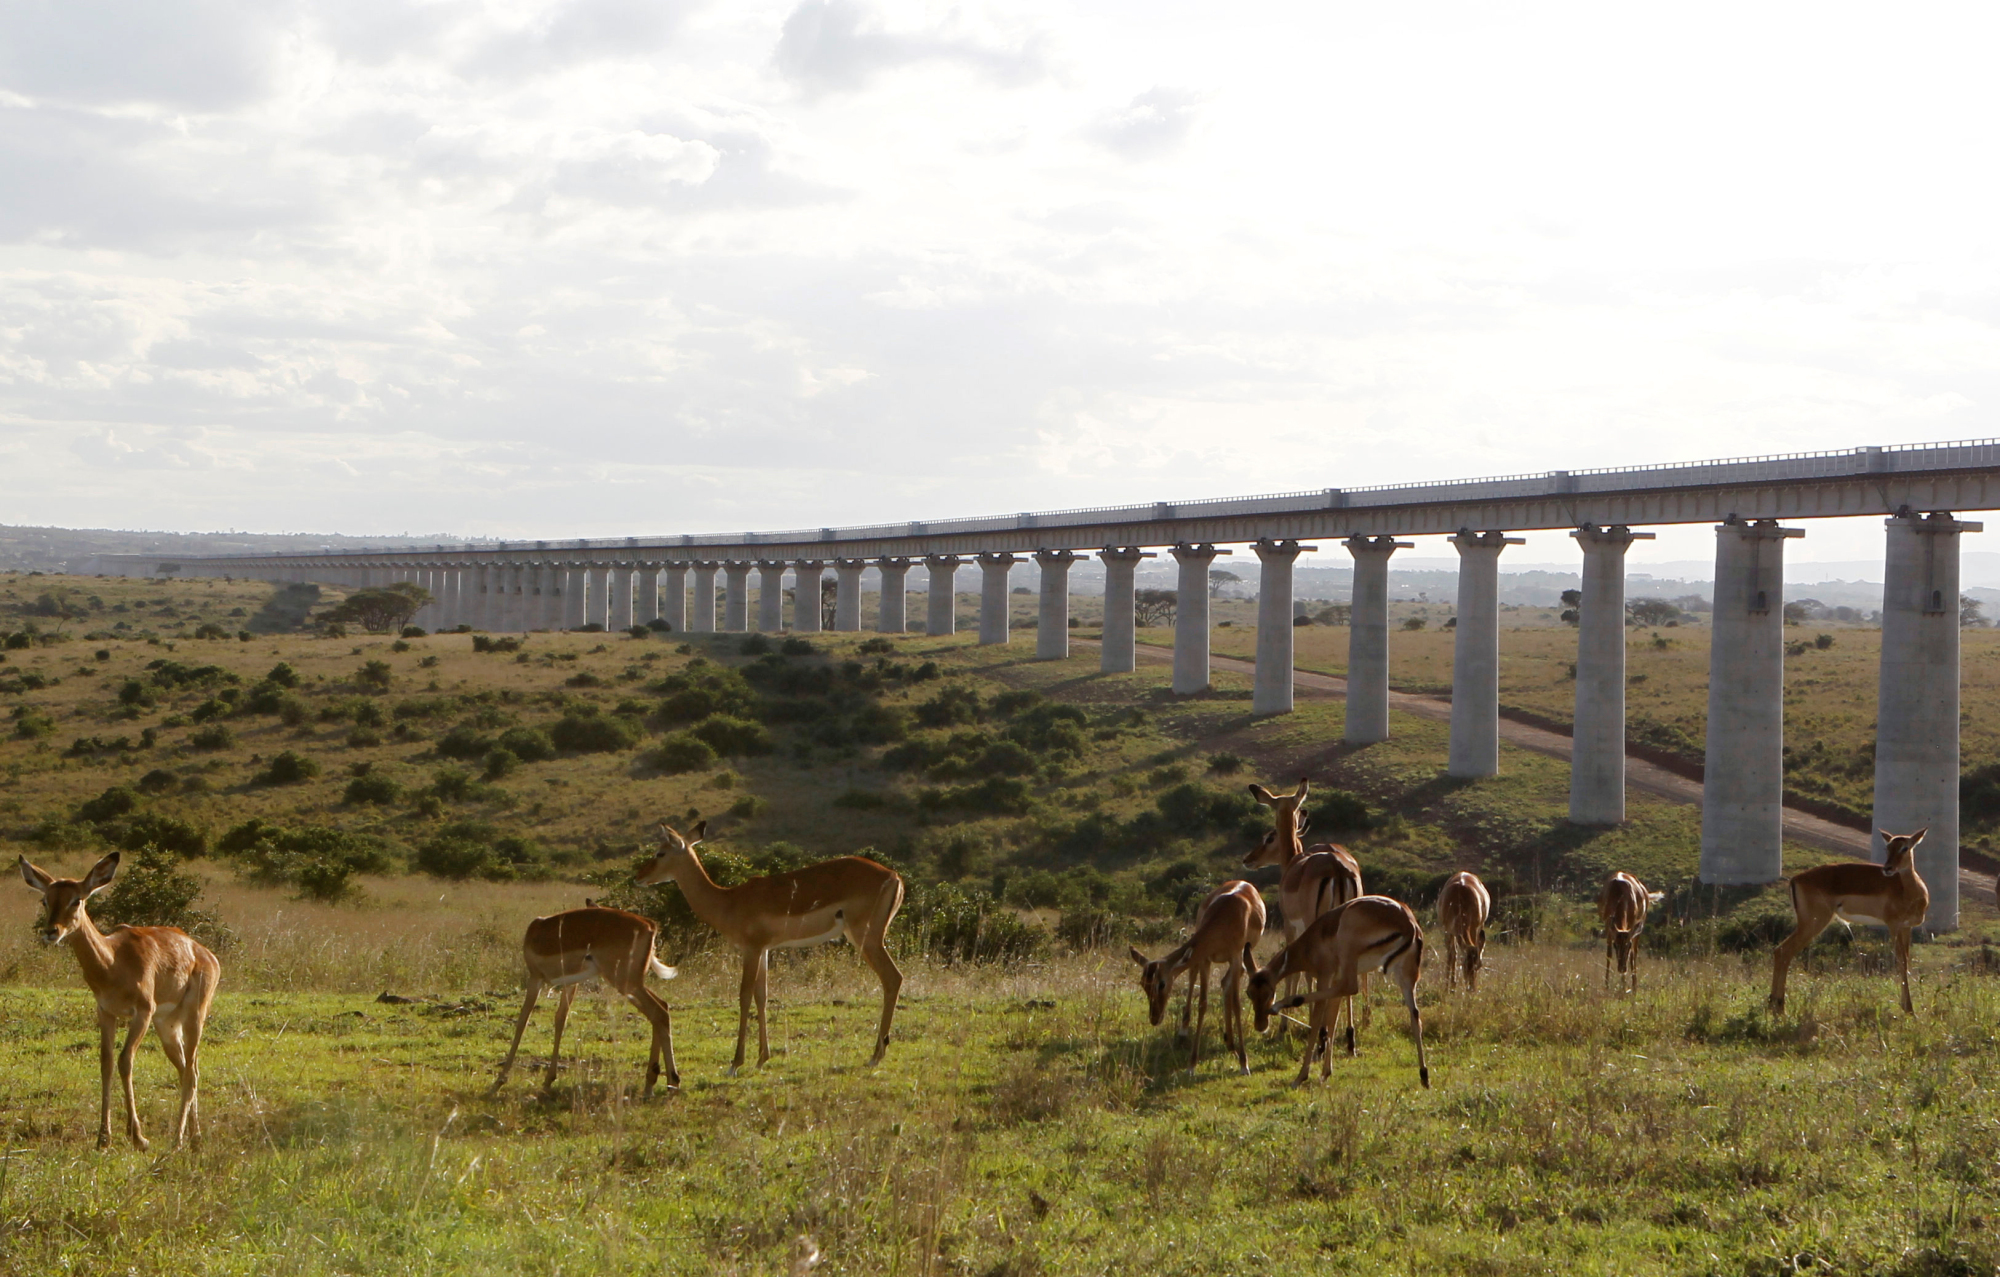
[494, 901, 680, 1095]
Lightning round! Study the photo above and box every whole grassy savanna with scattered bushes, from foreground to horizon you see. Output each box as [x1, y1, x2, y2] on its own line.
[0, 576, 2000, 1277]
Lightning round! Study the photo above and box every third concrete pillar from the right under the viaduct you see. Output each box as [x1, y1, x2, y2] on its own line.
[1570, 526, 1652, 825]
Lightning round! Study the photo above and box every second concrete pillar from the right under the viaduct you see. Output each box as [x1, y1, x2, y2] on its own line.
[1702, 516, 1806, 885]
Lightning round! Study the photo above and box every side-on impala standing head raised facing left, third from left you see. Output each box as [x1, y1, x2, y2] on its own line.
[638, 821, 902, 1073]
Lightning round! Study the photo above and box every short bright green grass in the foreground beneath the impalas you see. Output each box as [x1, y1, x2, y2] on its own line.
[0, 945, 2000, 1275]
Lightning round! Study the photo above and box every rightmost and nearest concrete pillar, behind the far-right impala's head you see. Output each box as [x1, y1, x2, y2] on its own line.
[1872, 510, 1984, 933]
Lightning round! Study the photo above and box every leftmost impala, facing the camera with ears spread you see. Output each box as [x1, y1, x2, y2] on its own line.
[20, 851, 222, 1151]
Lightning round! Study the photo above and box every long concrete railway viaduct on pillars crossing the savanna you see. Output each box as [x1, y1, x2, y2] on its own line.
[100, 440, 2000, 931]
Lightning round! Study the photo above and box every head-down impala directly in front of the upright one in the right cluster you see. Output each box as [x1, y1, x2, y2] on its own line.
[1244, 895, 1430, 1087]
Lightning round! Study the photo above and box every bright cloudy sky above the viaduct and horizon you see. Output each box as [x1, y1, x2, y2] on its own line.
[0, 0, 2000, 558]
